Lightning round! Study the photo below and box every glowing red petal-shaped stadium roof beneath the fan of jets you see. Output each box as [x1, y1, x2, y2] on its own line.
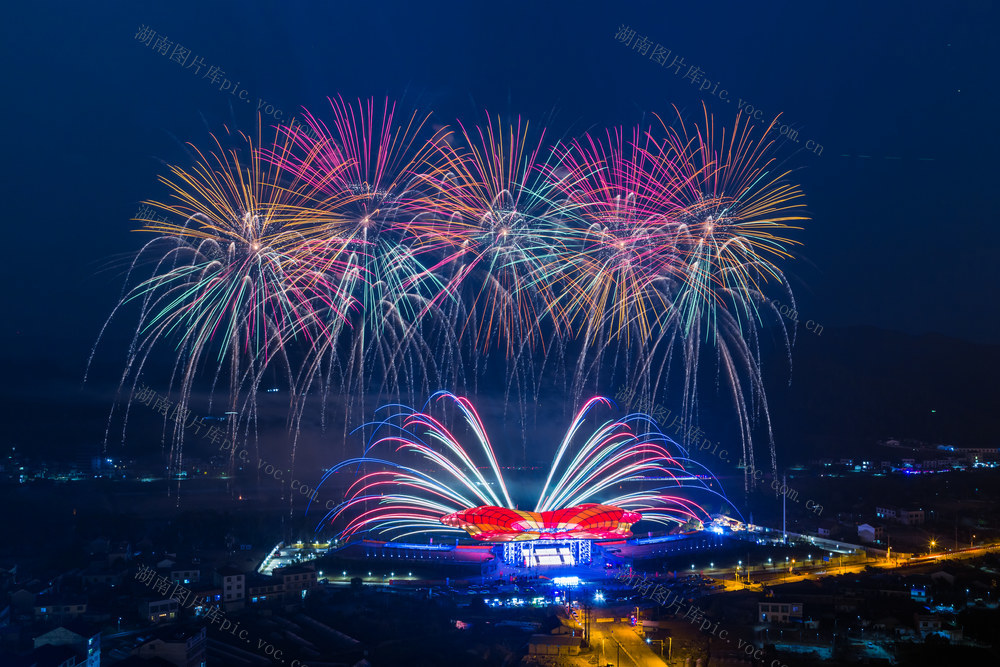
[441, 503, 642, 542]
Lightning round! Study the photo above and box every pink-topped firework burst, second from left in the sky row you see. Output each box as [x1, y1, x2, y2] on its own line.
[268, 97, 458, 454]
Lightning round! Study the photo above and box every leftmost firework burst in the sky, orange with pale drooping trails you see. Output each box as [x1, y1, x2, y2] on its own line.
[89, 118, 353, 486]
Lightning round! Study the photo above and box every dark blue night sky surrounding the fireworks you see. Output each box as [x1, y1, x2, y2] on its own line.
[0, 0, 1000, 468]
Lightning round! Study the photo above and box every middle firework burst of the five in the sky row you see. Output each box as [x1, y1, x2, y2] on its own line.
[414, 118, 569, 358]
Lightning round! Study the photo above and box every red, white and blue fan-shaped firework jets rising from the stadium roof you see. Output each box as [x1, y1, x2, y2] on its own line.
[307, 392, 728, 539]
